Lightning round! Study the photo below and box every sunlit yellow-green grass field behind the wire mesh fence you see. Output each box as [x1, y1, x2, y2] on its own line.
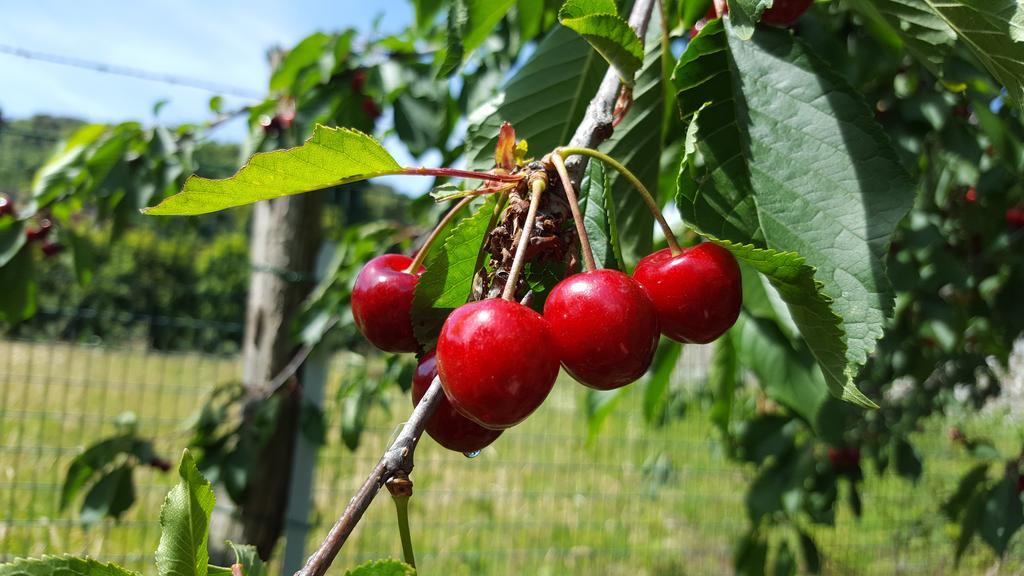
[0, 341, 1024, 576]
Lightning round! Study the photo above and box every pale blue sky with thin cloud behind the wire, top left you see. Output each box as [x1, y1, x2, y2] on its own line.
[0, 0, 429, 193]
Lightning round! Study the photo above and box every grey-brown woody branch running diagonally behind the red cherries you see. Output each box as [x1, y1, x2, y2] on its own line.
[295, 0, 656, 576]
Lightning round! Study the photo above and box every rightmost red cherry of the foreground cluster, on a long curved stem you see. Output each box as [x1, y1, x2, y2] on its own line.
[633, 242, 743, 344]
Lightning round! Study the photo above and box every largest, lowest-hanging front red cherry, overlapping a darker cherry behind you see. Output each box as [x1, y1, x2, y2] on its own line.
[437, 298, 559, 429]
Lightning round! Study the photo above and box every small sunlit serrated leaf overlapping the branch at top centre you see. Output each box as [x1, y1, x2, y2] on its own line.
[558, 0, 644, 86]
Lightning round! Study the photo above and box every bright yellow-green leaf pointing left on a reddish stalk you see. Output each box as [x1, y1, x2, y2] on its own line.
[142, 125, 401, 215]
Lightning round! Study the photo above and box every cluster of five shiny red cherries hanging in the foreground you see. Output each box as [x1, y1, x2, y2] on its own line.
[352, 217, 741, 453]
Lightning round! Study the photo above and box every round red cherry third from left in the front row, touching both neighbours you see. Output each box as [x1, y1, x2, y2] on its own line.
[544, 270, 659, 389]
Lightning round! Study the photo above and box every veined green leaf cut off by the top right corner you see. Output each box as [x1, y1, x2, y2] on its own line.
[923, 0, 1024, 107]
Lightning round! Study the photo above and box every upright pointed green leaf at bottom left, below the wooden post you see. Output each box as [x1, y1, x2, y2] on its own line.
[156, 450, 214, 576]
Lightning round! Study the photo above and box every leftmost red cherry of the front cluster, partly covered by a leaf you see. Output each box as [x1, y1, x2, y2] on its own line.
[352, 254, 424, 352]
